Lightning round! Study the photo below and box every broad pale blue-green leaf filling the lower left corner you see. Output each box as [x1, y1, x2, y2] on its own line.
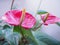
[0, 28, 20, 45]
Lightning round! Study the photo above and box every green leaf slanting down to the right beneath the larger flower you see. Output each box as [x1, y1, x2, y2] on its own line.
[22, 28, 38, 45]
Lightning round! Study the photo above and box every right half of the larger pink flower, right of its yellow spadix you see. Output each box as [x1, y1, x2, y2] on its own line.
[21, 13, 36, 29]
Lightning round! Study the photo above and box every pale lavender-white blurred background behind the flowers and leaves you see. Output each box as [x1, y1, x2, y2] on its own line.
[0, 0, 60, 41]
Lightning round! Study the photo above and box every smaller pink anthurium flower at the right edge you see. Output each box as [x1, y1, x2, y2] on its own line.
[41, 14, 60, 25]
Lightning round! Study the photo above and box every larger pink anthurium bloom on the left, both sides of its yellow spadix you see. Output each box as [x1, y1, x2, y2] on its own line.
[2, 10, 36, 29]
